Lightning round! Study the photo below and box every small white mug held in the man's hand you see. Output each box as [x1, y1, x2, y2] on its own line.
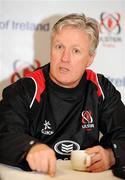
[71, 150, 91, 171]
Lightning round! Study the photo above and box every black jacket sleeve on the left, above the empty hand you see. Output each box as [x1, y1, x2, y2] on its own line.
[0, 78, 38, 168]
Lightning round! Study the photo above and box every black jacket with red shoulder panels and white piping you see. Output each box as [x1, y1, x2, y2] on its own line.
[0, 64, 125, 169]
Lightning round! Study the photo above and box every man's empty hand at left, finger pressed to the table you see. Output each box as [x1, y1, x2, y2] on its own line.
[26, 144, 56, 176]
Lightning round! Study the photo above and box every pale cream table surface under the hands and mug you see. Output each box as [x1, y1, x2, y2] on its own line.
[0, 160, 120, 180]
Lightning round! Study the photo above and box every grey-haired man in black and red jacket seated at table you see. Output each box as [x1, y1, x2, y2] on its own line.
[0, 14, 125, 176]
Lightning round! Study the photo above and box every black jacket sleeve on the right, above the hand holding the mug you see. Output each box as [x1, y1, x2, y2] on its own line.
[99, 74, 125, 166]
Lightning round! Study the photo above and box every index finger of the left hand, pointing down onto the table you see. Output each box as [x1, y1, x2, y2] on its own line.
[48, 156, 56, 177]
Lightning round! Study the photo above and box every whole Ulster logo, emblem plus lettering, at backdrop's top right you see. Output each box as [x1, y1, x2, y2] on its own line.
[100, 12, 122, 48]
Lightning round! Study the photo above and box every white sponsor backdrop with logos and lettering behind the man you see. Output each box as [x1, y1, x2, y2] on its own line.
[0, 0, 125, 103]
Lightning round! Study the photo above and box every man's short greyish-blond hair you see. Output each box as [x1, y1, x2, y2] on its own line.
[52, 13, 99, 54]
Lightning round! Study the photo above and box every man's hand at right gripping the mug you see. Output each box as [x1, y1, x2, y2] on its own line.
[86, 146, 115, 172]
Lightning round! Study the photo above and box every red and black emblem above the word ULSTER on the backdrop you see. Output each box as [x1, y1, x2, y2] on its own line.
[100, 12, 121, 34]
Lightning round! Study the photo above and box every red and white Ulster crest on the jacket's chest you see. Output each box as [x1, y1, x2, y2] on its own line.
[82, 111, 94, 131]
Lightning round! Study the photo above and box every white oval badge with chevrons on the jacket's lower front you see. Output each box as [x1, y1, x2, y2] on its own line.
[54, 140, 80, 155]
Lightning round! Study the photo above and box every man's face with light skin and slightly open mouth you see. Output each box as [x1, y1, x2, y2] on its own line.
[50, 26, 94, 88]
